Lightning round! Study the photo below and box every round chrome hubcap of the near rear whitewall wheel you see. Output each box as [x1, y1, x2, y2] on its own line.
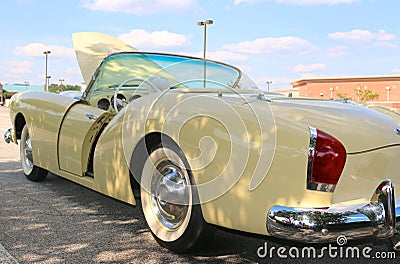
[151, 161, 190, 229]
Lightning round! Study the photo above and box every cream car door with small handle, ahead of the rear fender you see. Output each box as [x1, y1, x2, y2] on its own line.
[58, 104, 110, 176]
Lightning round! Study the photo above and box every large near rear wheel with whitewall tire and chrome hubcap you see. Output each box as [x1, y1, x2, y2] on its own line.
[141, 143, 213, 253]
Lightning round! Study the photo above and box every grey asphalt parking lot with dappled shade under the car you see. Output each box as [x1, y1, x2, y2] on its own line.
[0, 104, 400, 263]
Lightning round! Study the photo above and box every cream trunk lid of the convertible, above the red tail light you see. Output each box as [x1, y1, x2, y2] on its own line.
[270, 99, 400, 154]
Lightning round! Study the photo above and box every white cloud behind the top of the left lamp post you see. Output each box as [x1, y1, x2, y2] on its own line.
[14, 43, 75, 58]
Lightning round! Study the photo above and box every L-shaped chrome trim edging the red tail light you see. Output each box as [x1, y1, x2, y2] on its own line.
[306, 127, 336, 192]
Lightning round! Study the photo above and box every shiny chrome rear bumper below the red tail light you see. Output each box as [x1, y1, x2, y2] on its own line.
[267, 180, 400, 250]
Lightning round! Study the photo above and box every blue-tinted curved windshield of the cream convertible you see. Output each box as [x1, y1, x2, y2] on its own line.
[87, 52, 256, 93]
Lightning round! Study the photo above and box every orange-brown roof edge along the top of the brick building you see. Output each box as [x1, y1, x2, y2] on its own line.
[290, 75, 400, 87]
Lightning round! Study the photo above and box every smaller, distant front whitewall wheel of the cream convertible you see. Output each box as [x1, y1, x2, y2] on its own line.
[19, 125, 48, 181]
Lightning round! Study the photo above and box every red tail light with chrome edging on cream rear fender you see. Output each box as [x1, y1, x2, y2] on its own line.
[307, 127, 347, 191]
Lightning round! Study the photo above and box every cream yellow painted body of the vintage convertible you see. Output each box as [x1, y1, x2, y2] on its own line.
[5, 32, 400, 251]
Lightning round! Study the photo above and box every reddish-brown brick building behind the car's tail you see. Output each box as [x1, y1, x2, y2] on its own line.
[291, 76, 400, 108]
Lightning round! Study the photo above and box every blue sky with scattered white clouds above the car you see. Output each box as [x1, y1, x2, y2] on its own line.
[0, 0, 400, 89]
